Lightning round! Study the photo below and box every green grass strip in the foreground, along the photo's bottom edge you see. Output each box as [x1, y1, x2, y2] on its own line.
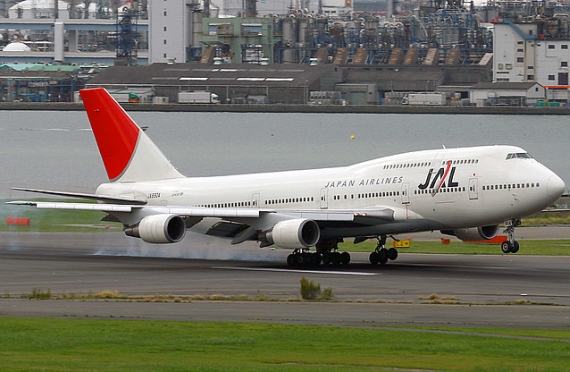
[0, 318, 570, 372]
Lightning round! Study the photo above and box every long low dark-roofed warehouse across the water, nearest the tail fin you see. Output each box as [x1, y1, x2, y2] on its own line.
[87, 63, 342, 104]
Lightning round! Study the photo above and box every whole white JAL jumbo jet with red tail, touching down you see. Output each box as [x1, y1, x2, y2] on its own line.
[9, 88, 566, 267]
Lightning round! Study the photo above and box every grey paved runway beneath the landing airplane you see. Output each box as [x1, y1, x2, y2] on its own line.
[0, 229, 570, 329]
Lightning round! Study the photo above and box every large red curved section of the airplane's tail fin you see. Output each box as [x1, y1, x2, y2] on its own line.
[79, 88, 140, 181]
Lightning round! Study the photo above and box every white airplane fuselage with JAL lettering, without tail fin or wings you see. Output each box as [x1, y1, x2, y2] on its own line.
[97, 146, 565, 237]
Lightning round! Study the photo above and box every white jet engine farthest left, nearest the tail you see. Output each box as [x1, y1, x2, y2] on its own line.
[125, 214, 186, 244]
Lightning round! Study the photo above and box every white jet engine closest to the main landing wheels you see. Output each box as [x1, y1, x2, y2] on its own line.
[259, 218, 321, 249]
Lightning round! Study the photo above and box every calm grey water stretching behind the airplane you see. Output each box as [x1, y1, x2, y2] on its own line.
[0, 111, 570, 198]
